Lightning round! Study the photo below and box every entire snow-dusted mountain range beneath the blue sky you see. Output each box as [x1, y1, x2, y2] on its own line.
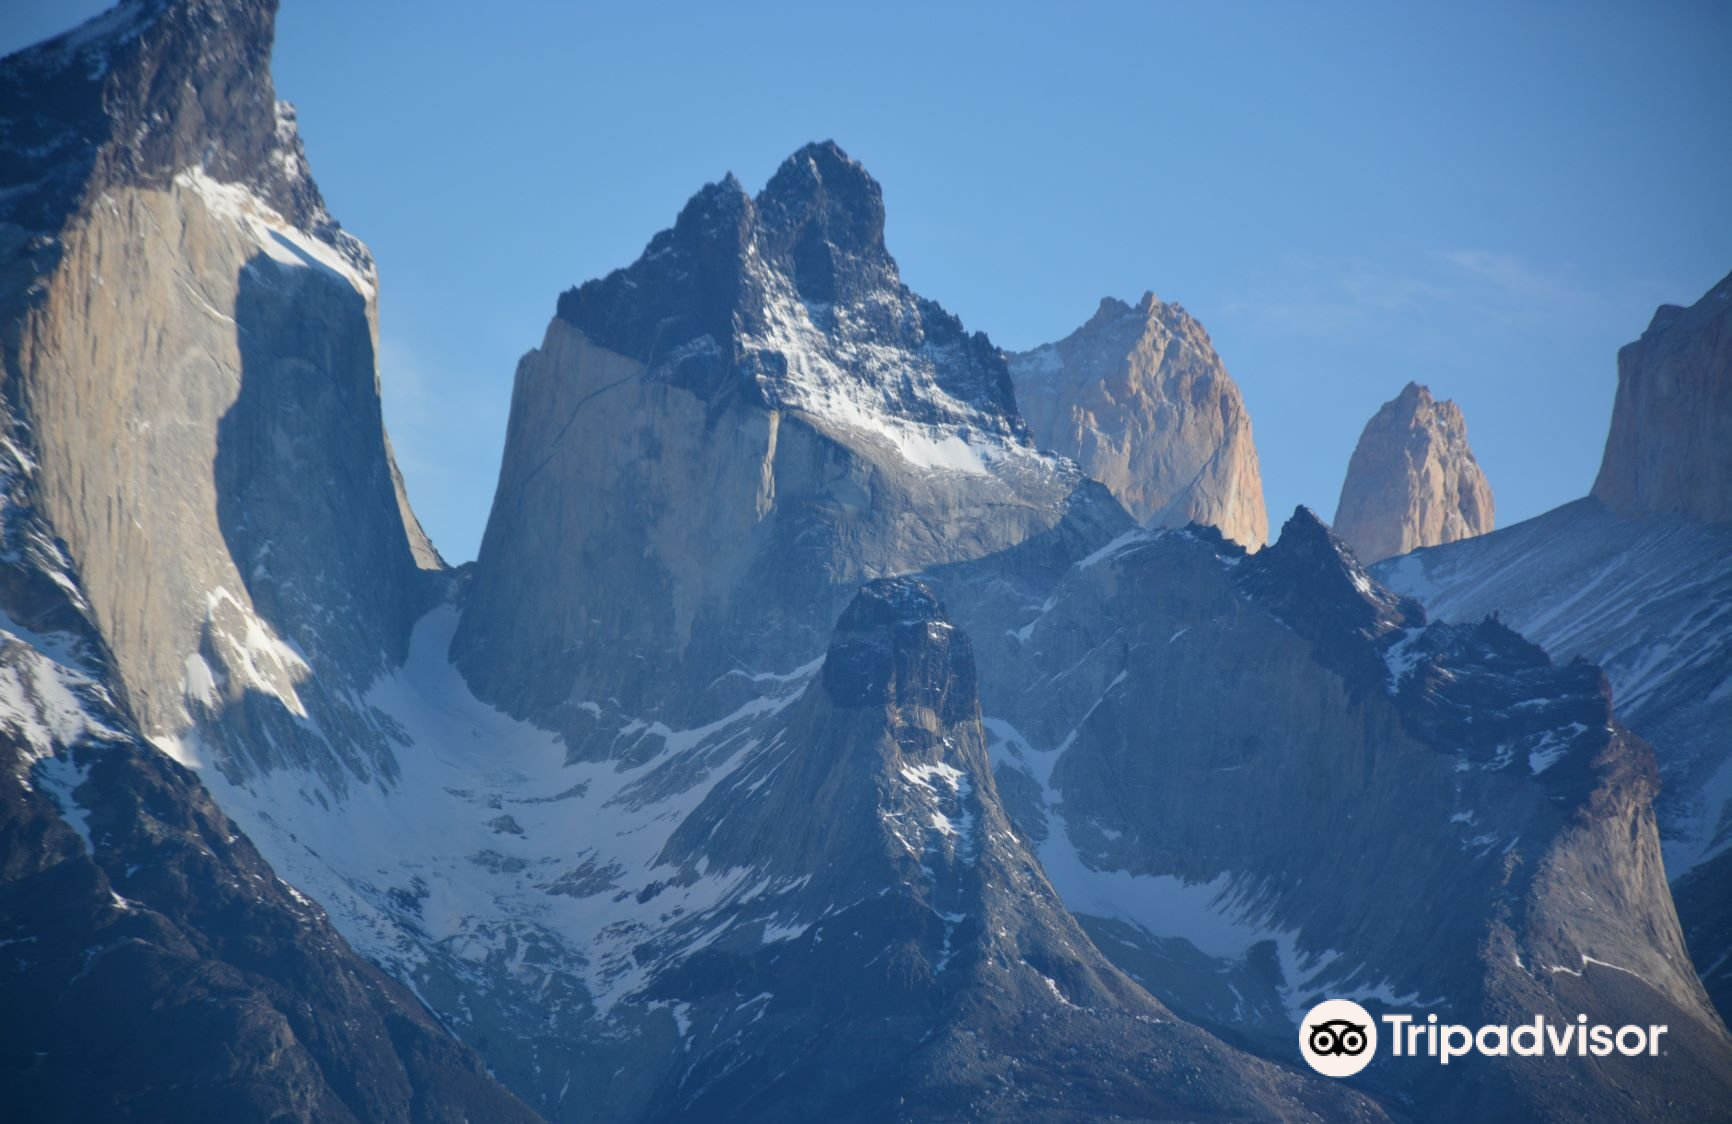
[0, 0, 1732, 1122]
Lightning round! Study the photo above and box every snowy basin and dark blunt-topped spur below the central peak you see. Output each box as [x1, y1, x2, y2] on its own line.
[209, 580, 1377, 1121]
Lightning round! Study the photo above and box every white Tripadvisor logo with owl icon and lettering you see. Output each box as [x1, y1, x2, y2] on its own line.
[1299, 999, 1666, 1077]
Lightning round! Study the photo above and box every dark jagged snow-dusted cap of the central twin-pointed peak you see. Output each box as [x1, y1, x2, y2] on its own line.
[558, 140, 1029, 438]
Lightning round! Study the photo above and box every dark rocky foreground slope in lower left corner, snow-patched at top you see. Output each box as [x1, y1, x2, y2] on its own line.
[0, 616, 535, 1124]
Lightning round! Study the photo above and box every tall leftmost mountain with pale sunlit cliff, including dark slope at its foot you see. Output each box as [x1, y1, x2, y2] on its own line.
[0, 0, 537, 1122]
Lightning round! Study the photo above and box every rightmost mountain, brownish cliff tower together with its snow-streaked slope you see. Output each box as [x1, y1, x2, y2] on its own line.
[1377, 264, 1732, 1017]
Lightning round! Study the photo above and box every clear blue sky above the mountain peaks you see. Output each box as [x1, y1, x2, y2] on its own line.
[0, 0, 1732, 561]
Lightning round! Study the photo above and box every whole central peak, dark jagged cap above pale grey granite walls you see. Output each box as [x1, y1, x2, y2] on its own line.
[454, 144, 1124, 755]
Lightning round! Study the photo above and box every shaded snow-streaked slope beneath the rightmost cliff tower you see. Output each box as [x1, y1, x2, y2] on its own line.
[1375, 497, 1732, 1017]
